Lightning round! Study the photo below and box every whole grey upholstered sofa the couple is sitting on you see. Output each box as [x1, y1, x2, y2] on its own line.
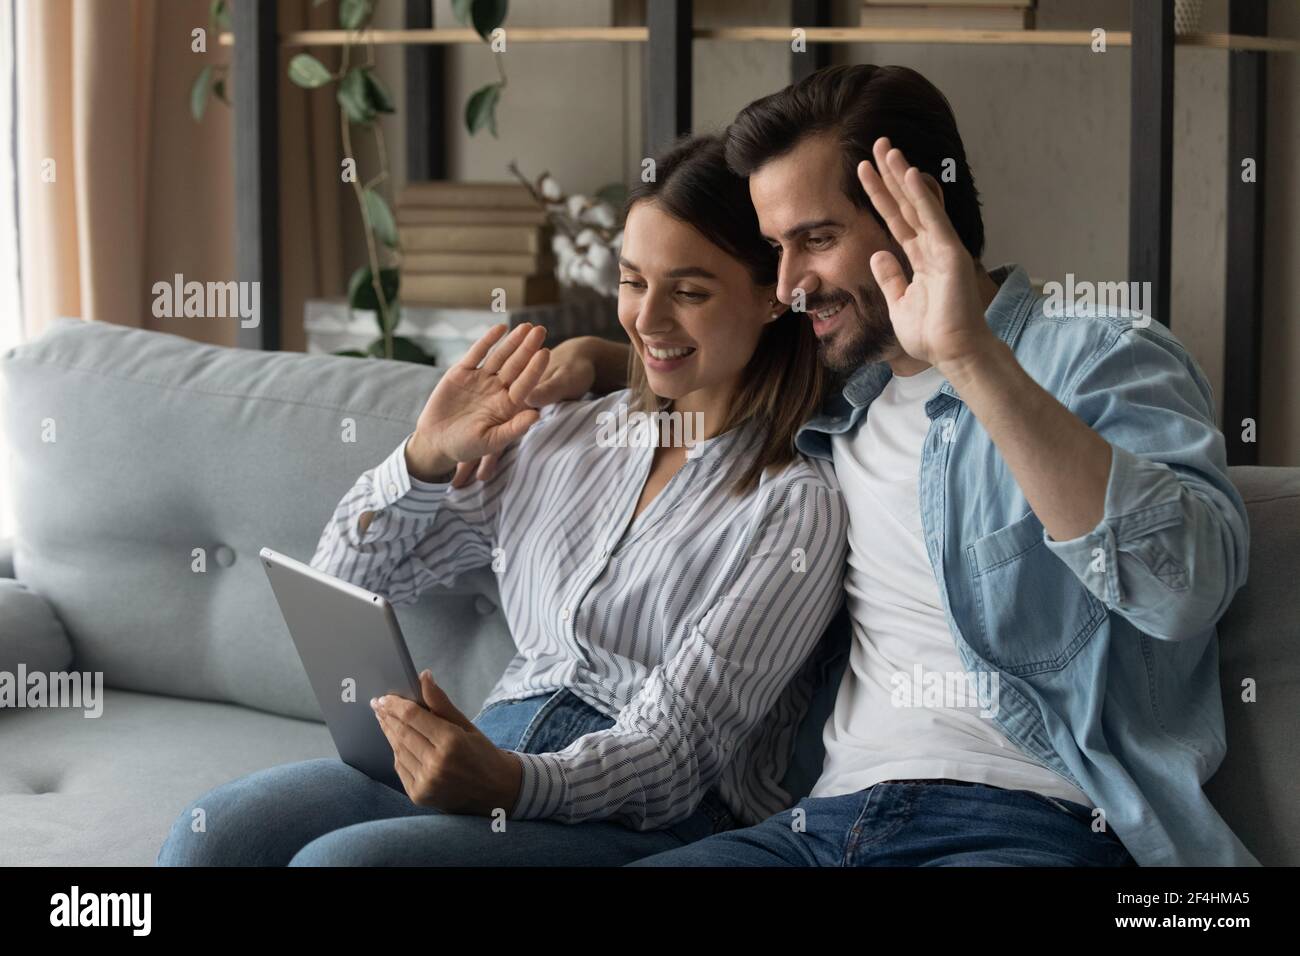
[0, 319, 1300, 865]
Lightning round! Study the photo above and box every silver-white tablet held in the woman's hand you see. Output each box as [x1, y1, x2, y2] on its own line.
[261, 548, 421, 793]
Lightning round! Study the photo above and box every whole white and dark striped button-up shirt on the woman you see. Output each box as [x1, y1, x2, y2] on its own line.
[312, 390, 848, 830]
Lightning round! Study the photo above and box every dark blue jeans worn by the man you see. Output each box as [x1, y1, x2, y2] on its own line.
[629, 780, 1135, 866]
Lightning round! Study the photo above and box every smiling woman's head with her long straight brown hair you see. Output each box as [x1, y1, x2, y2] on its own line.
[619, 137, 824, 502]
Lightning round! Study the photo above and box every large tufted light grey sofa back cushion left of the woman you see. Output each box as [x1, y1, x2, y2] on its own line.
[0, 319, 514, 719]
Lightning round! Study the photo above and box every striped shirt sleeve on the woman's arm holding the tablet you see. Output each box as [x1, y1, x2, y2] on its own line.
[501, 480, 848, 830]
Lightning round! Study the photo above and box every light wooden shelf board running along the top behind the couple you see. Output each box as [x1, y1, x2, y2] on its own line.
[220, 26, 1300, 53]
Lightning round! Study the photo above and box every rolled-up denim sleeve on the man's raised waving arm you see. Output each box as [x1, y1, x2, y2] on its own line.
[1044, 329, 1249, 640]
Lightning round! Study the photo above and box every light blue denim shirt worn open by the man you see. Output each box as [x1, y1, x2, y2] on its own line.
[796, 265, 1257, 866]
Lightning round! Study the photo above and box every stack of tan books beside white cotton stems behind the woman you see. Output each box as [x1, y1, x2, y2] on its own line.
[397, 181, 559, 310]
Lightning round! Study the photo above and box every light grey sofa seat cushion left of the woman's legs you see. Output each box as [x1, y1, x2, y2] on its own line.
[0, 689, 338, 866]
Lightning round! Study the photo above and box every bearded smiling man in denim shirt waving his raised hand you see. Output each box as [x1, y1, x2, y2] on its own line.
[525, 65, 1255, 866]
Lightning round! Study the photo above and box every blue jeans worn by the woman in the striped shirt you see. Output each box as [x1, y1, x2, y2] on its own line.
[157, 689, 736, 866]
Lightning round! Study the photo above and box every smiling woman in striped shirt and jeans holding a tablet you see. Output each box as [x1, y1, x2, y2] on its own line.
[159, 130, 848, 866]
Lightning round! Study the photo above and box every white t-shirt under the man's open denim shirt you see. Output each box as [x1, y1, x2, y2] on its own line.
[811, 368, 1092, 806]
